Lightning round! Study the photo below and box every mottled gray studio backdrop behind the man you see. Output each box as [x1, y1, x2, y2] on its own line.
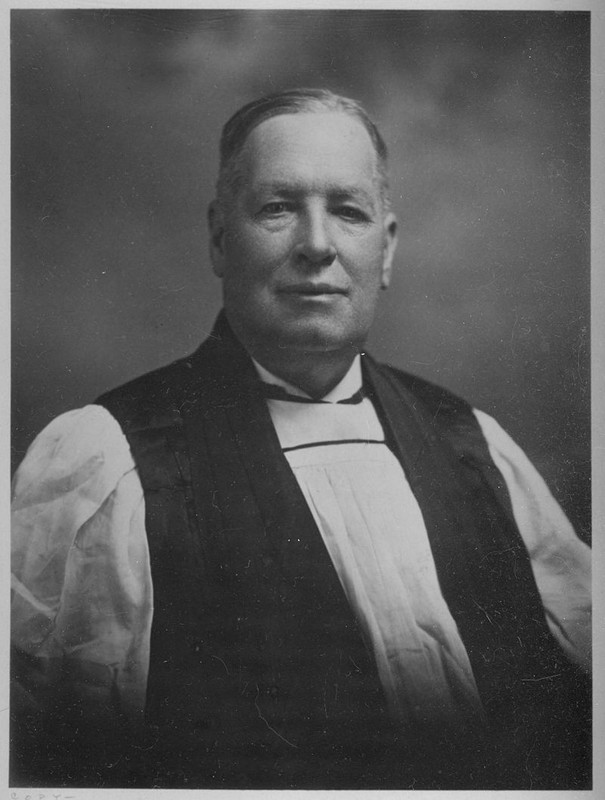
[11, 10, 590, 535]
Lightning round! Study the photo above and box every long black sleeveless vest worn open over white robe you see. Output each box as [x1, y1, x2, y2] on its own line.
[97, 315, 587, 788]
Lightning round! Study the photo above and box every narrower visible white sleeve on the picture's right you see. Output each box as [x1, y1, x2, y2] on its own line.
[474, 411, 592, 671]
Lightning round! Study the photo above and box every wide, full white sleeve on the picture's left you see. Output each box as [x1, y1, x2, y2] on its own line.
[11, 405, 153, 717]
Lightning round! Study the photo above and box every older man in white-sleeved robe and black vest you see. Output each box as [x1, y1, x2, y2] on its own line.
[13, 90, 590, 788]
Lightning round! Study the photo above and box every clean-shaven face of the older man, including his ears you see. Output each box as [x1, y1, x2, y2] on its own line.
[210, 112, 396, 352]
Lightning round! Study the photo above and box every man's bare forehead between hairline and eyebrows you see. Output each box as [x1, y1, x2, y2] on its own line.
[240, 111, 378, 193]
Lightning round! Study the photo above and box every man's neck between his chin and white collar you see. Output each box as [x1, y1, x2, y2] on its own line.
[247, 348, 358, 399]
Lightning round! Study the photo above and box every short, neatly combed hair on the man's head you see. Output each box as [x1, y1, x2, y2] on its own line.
[216, 88, 388, 206]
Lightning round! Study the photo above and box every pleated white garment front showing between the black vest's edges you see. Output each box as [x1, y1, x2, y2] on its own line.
[263, 362, 482, 728]
